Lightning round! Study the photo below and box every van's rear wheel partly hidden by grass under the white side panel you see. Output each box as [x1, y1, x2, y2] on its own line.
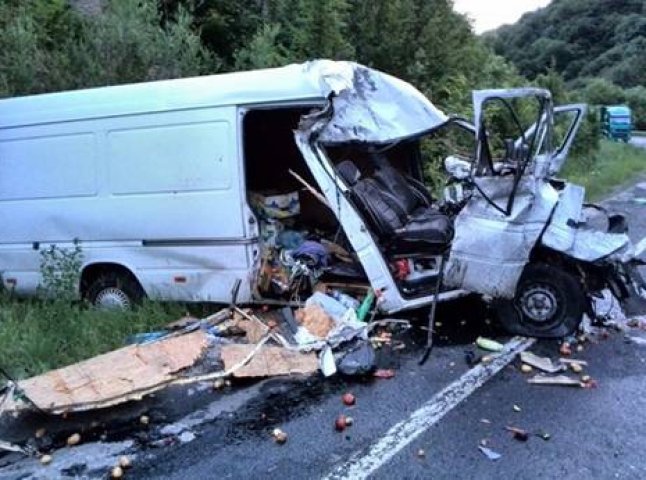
[86, 272, 146, 310]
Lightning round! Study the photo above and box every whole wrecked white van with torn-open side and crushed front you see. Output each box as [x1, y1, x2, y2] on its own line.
[0, 61, 646, 337]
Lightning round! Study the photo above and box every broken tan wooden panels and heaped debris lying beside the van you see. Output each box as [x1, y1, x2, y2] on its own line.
[2, 291, 408, 420]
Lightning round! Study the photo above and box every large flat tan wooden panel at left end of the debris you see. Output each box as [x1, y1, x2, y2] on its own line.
[12, 330, 207, 412]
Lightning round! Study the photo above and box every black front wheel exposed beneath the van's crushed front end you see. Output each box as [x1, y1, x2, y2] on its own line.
[494, 264, 587, 338]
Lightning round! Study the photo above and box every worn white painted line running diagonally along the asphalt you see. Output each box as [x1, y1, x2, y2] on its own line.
[324, 337, 535, 480]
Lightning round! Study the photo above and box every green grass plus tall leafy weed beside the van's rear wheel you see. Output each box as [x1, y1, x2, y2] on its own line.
[0, 243, 181, 385]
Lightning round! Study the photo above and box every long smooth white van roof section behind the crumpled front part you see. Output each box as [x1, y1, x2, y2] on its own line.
[0, 62, 327, 128]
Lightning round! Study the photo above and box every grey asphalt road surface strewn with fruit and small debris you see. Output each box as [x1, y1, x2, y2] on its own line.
[0, 171, 646, 480]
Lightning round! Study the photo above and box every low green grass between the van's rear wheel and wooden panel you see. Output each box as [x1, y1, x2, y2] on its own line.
[0, 297, 184, 385]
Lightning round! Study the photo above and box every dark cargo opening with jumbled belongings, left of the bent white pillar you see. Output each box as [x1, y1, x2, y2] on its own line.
[243, 108, 369, 302]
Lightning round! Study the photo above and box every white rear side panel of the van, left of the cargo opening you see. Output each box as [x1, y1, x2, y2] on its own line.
[0, 107, 257, 301]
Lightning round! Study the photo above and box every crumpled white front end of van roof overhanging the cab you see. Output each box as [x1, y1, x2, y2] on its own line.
[300, 60, 448, 144]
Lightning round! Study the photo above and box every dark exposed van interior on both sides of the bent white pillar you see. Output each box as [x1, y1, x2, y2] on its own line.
[243, 108, 453, 301]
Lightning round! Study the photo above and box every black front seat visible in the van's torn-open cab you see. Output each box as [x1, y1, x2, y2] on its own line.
[337, 160, 453, 254]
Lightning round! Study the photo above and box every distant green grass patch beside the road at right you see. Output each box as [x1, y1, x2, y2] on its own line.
[561, 140, 646, 201]
